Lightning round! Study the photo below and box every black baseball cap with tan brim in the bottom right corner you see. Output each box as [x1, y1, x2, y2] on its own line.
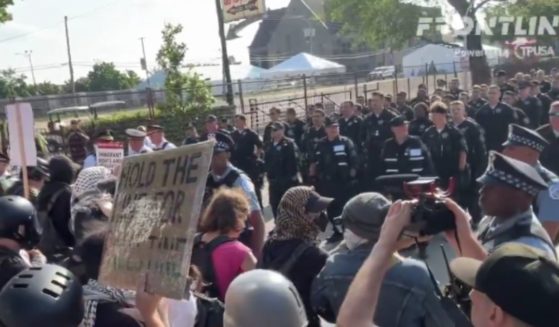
[450, 242, 559, 326]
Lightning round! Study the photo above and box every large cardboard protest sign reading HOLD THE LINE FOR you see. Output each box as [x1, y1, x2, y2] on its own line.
[100, 141, 214, 299]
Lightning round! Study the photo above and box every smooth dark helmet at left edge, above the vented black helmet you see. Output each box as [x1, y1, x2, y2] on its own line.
[0, 195, 43, 249]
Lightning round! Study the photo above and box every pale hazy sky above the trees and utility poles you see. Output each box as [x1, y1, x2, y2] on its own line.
[0, 0, 289, 83]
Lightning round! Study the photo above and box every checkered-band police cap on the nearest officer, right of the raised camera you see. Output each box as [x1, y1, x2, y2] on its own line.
[477, 151, 547, 197]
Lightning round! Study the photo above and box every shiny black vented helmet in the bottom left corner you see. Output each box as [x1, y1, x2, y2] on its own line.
[0, 264, 84, 327]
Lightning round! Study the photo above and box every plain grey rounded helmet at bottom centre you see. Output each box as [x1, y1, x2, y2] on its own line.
[223, 269, 308, 327]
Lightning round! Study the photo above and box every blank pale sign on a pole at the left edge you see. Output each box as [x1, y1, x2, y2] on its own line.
[6, 103, 37, 167]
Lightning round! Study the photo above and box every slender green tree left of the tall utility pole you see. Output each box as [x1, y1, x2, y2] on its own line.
[157, 24, 215, 123]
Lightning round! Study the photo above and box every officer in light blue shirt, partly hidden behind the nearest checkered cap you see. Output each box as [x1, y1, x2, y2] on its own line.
[503, 125, 559, 240]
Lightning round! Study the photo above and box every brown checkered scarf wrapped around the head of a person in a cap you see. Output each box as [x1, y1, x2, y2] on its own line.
[270, 186, 320, 242]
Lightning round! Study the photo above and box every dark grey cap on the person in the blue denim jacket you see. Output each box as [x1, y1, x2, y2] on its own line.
[341, 192, 391, 242]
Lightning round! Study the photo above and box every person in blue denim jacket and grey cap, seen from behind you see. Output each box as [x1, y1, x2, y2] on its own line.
[311, 193, 454, 327]
